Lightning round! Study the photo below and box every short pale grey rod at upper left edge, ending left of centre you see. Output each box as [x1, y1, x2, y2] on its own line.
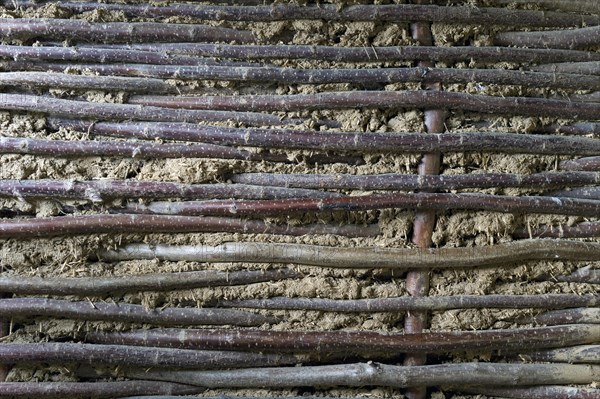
[0, 71, 178, 94]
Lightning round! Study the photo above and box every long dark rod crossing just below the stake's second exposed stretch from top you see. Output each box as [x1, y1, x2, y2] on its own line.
[47, 118, 600, 155]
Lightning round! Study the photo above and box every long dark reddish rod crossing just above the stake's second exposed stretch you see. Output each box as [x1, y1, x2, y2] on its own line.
[123, 91, 600, 120]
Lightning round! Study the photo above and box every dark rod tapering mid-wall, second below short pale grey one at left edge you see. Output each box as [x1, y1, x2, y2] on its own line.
[0, 137, 289, 162]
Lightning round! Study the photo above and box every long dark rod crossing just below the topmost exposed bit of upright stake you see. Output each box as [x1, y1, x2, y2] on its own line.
[85, 43, 600, 65]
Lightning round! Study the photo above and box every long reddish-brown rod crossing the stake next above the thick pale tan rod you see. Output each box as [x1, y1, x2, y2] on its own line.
[116, 193, 600, 219]
